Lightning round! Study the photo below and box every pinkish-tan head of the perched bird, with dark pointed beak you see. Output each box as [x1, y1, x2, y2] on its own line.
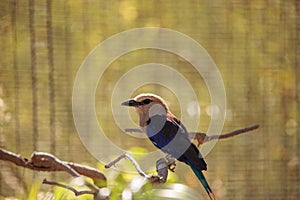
[122, 93, 171, 127]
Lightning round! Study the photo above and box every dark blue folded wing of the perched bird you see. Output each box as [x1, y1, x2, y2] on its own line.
[147, 115, 206, 170]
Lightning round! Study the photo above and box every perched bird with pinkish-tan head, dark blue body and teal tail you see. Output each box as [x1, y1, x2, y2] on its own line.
[121, 93, 215, 199]
